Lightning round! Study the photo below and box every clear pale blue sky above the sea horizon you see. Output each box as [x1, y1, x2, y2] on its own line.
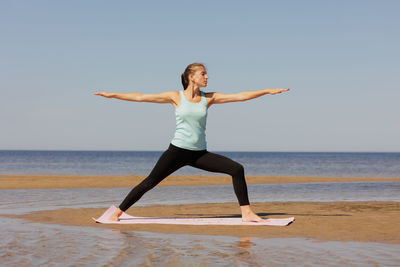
[0, 0, 400, 152]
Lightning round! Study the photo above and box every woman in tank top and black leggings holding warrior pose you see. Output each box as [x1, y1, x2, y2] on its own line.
[95, 63, 289, 222]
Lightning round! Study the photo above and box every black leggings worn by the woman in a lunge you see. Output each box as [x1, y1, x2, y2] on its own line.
[119, 144, 249, 211]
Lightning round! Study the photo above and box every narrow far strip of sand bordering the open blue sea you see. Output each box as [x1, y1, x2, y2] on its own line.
[0, 174, 400, 189]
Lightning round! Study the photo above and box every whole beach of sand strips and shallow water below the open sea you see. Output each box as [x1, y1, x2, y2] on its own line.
[0, 174, 400, 266]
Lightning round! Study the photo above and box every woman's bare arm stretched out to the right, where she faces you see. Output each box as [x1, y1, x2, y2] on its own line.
[209, 88, 290, 106]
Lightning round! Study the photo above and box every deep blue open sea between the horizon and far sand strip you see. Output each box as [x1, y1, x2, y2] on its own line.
[0, 150, 400, 177]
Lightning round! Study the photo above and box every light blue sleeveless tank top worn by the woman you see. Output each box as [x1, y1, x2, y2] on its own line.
[171, 91, 207, 150]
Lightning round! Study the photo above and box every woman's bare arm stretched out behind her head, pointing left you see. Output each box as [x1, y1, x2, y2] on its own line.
[94, 91, 177, 104]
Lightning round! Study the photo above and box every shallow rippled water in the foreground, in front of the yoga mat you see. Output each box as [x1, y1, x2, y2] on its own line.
[0, 217, 400, 267]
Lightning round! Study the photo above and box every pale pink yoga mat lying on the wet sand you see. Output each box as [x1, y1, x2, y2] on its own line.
[93, 206, 294, 226]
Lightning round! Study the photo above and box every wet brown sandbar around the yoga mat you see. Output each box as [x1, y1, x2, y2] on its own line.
[2, 202, 400, 244]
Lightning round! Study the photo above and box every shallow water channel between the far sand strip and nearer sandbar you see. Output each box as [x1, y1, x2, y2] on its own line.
[0, 181, 400, 214]
